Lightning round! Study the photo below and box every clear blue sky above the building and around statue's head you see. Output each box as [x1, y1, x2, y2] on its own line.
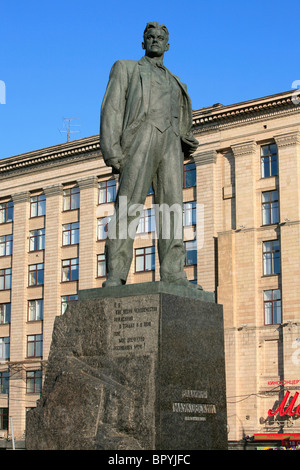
[0, 0, 300, 158]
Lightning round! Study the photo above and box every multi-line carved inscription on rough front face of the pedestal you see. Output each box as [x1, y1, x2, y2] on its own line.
[110, 296, 159, 356]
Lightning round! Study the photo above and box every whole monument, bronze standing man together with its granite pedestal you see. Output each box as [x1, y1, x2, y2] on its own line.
[26, 22, 227, 452]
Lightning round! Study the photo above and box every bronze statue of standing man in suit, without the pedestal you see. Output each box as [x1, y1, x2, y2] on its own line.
[100, 22, 199, 287]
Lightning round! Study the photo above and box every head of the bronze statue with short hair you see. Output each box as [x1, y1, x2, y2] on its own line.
[142, 21, 170, 57]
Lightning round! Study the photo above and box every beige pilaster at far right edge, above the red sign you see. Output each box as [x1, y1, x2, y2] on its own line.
[274, 129, 300, 379]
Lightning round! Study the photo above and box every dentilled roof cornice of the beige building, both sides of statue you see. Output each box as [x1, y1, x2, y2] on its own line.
[0, 91, 300, 179]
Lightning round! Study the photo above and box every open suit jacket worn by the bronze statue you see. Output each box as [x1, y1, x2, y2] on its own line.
[100, 57, 198, 164]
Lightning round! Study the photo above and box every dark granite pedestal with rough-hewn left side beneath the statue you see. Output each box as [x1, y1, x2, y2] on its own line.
[26, 282, 227, 450]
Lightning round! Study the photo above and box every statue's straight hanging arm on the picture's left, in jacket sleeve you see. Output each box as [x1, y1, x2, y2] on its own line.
[100, 61, 128, 170]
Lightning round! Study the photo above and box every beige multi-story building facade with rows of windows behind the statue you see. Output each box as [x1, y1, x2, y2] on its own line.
[0, 92, 300, 447]
